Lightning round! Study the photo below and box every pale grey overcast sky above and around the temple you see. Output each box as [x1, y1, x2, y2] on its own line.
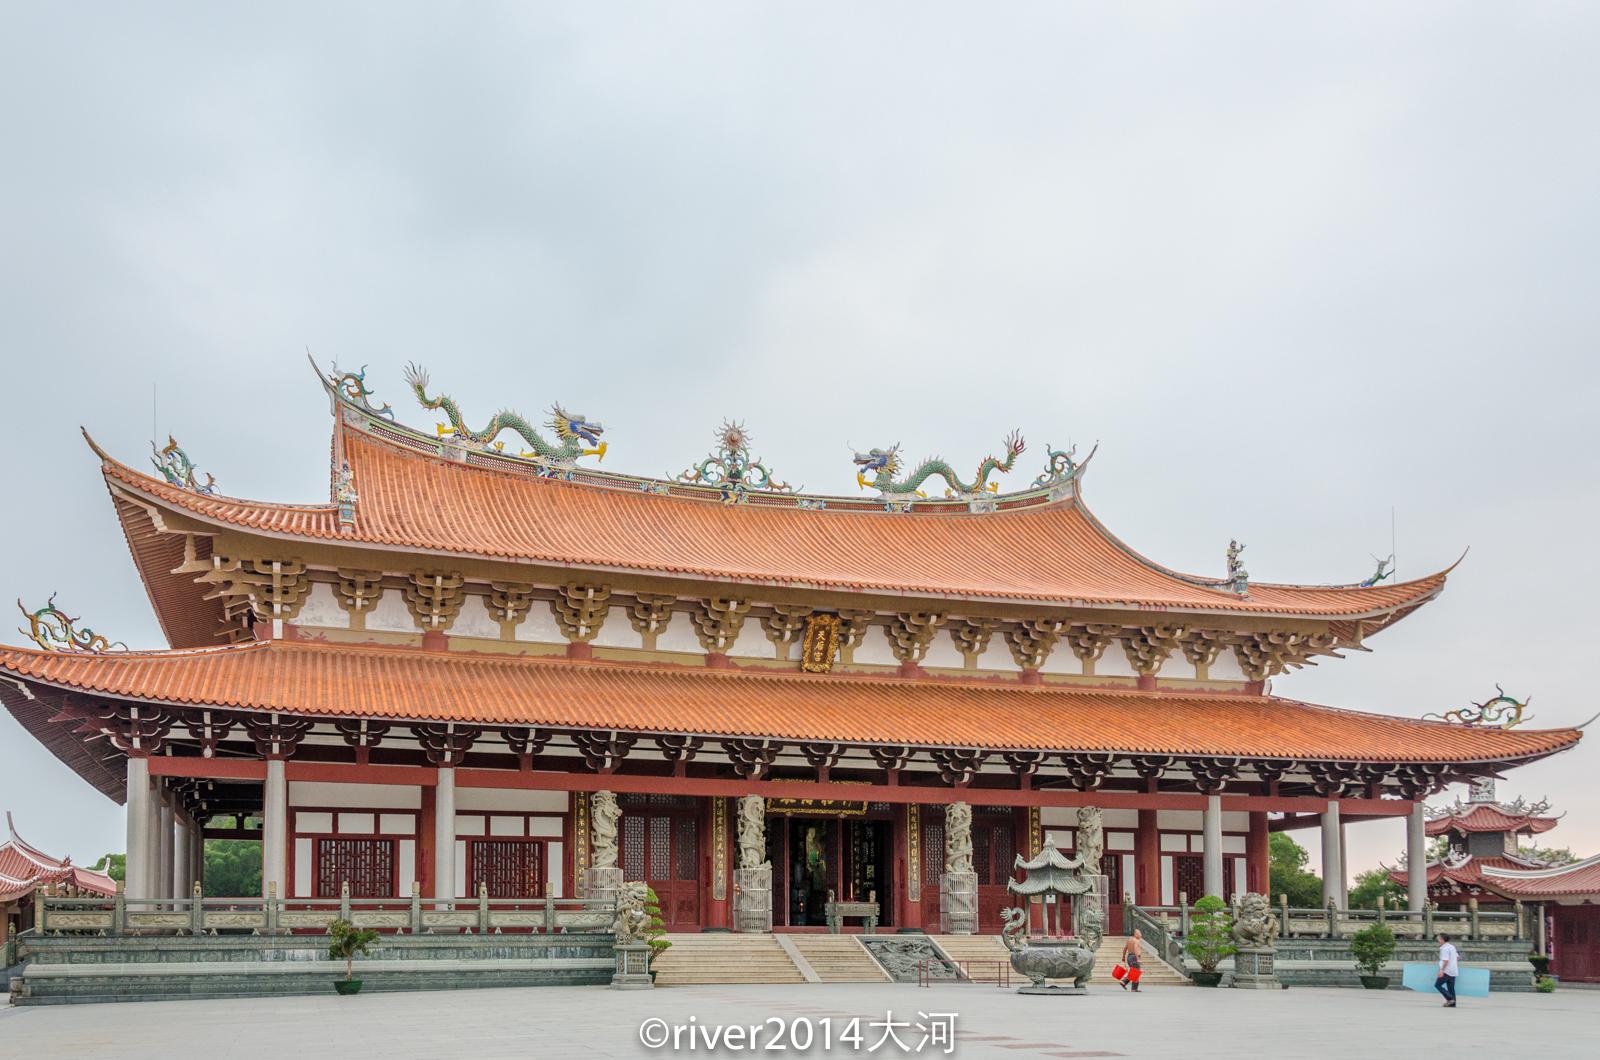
[0, 0, 1600, 869]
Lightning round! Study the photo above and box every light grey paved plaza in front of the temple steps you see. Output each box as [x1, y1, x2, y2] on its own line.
[0, 983, 1600, 1060]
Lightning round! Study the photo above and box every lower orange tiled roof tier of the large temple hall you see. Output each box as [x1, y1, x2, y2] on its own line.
[0, 640, 1581, 764]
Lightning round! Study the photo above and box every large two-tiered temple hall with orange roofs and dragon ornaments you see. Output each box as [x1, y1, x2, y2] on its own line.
[0, 370, 1581, 932]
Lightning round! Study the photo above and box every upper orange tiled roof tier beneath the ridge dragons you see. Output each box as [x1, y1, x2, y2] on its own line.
[104, 428, 1446, 618]
